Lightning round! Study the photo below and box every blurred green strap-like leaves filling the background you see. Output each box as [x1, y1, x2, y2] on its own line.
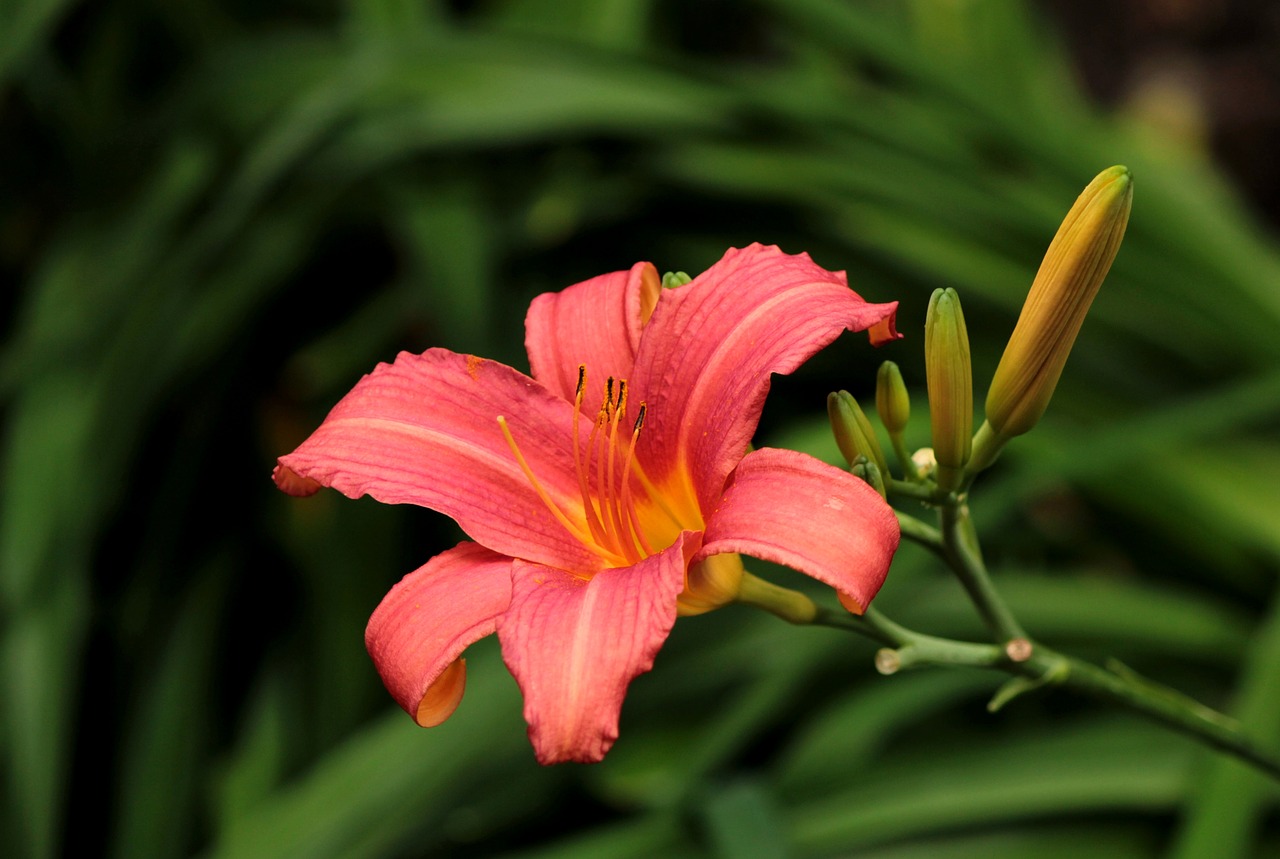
[0, 0, 1280, 859]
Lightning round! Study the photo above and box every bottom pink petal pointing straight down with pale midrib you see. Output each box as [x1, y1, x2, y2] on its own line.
[498, 533, 698, 763]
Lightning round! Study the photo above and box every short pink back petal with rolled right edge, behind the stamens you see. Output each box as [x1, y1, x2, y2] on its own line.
[525, 262, 662, 404]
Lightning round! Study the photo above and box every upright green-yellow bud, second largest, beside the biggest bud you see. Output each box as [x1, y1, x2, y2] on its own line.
[924, 288, 973, 492]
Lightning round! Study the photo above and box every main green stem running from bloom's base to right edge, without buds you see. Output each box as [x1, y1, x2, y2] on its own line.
[739, 574, 1280, 781]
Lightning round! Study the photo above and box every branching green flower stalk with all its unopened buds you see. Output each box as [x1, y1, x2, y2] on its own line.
[739, 166, 1280, 781]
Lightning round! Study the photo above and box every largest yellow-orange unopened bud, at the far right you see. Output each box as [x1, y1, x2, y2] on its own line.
[987, 166, 1133, 439]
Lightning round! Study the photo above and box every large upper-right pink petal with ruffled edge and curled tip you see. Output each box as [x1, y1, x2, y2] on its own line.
[631, 245, 897, 511]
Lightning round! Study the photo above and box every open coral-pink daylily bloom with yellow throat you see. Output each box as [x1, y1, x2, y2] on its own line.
[274, 245, 899, 763]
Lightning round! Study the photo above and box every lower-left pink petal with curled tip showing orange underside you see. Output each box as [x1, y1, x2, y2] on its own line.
[365, 543, 512, 727]
